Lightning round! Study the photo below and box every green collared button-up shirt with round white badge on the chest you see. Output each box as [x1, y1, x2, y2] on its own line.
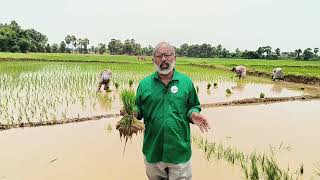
[136, 70, 201, 164]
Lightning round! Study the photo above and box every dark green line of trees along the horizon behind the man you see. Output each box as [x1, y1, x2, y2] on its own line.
[0, 21, 320, 60]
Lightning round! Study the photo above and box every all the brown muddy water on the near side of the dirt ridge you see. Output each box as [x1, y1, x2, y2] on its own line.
[0, 101, 320, 180]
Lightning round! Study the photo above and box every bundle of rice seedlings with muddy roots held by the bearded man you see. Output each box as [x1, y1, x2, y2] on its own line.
[116, 90, 144, 153]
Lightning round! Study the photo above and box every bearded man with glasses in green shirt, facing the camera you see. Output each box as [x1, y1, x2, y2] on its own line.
[136, 42, 210, 180]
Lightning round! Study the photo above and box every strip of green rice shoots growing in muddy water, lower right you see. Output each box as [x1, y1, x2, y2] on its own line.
[192, 135, 302, 180]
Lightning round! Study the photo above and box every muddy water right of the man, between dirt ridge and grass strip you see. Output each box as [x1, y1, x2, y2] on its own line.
[198, 101, 320, 179]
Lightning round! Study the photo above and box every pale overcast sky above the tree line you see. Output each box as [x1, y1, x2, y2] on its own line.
[0, 0, 320, 51]
